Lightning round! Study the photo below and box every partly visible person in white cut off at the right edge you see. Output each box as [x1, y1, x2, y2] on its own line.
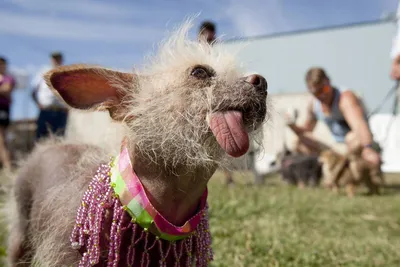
[390, 1, 400, 114]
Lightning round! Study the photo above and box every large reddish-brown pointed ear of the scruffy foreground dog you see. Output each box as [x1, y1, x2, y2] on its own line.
[44, 65, 136, 120]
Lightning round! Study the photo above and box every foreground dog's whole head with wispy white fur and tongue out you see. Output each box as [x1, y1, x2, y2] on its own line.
[45, 19, 267, 169]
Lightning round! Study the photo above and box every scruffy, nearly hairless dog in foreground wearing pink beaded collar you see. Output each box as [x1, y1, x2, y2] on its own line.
[8, 21, 268, 267]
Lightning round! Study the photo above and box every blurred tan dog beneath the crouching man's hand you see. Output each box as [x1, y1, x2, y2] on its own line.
[319, 149, 383, 198]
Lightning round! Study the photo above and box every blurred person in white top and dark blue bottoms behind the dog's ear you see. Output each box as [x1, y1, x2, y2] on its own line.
[32, 52, 68, 140]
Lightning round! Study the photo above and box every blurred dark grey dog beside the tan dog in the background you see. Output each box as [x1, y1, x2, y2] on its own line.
[278, 147, 322, 188]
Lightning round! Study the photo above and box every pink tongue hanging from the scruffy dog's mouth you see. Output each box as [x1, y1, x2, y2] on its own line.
[209, 111, 249, 157]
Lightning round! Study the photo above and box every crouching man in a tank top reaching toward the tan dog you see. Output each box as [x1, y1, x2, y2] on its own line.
[287, 67, 381, 166]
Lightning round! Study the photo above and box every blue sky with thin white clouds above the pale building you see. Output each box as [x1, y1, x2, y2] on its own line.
[0, 0, 398, 119]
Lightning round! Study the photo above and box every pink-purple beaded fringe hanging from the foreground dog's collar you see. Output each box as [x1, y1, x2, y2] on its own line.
[70, 164, 213, 267]
